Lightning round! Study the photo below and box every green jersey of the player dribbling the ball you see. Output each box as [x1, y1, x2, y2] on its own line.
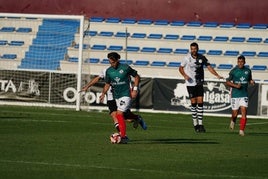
[105, 63, 137, 99]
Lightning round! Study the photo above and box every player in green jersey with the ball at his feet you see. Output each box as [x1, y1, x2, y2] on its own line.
[100, 52, 140, 143]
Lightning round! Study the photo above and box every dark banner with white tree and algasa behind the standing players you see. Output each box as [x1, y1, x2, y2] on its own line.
[153, 79, 258, 115]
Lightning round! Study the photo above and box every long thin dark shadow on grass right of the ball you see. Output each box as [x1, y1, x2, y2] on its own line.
[130, 139, 219, 144]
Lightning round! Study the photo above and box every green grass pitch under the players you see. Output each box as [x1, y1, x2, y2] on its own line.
[0, 106, 268, 179]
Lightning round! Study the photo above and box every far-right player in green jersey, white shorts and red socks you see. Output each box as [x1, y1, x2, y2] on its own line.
[226, 55, 255, 136]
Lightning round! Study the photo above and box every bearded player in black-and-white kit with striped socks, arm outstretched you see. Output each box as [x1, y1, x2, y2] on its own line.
[179, 42, 222, 132]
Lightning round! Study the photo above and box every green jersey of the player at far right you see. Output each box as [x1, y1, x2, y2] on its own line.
[226, 67, 252, 98]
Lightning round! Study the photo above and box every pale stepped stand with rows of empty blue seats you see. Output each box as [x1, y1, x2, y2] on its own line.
[0, 17, 268, 80]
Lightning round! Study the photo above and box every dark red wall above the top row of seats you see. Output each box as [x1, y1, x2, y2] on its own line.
[0, 0, 268, 24]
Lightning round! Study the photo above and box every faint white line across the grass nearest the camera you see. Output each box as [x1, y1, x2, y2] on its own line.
[0, 159, 262, 179]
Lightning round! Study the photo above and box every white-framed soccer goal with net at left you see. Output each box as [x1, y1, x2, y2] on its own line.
[0, 13, 86, 110]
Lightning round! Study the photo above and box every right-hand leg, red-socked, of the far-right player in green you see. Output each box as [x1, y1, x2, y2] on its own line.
[239, 98, 248, 136]
